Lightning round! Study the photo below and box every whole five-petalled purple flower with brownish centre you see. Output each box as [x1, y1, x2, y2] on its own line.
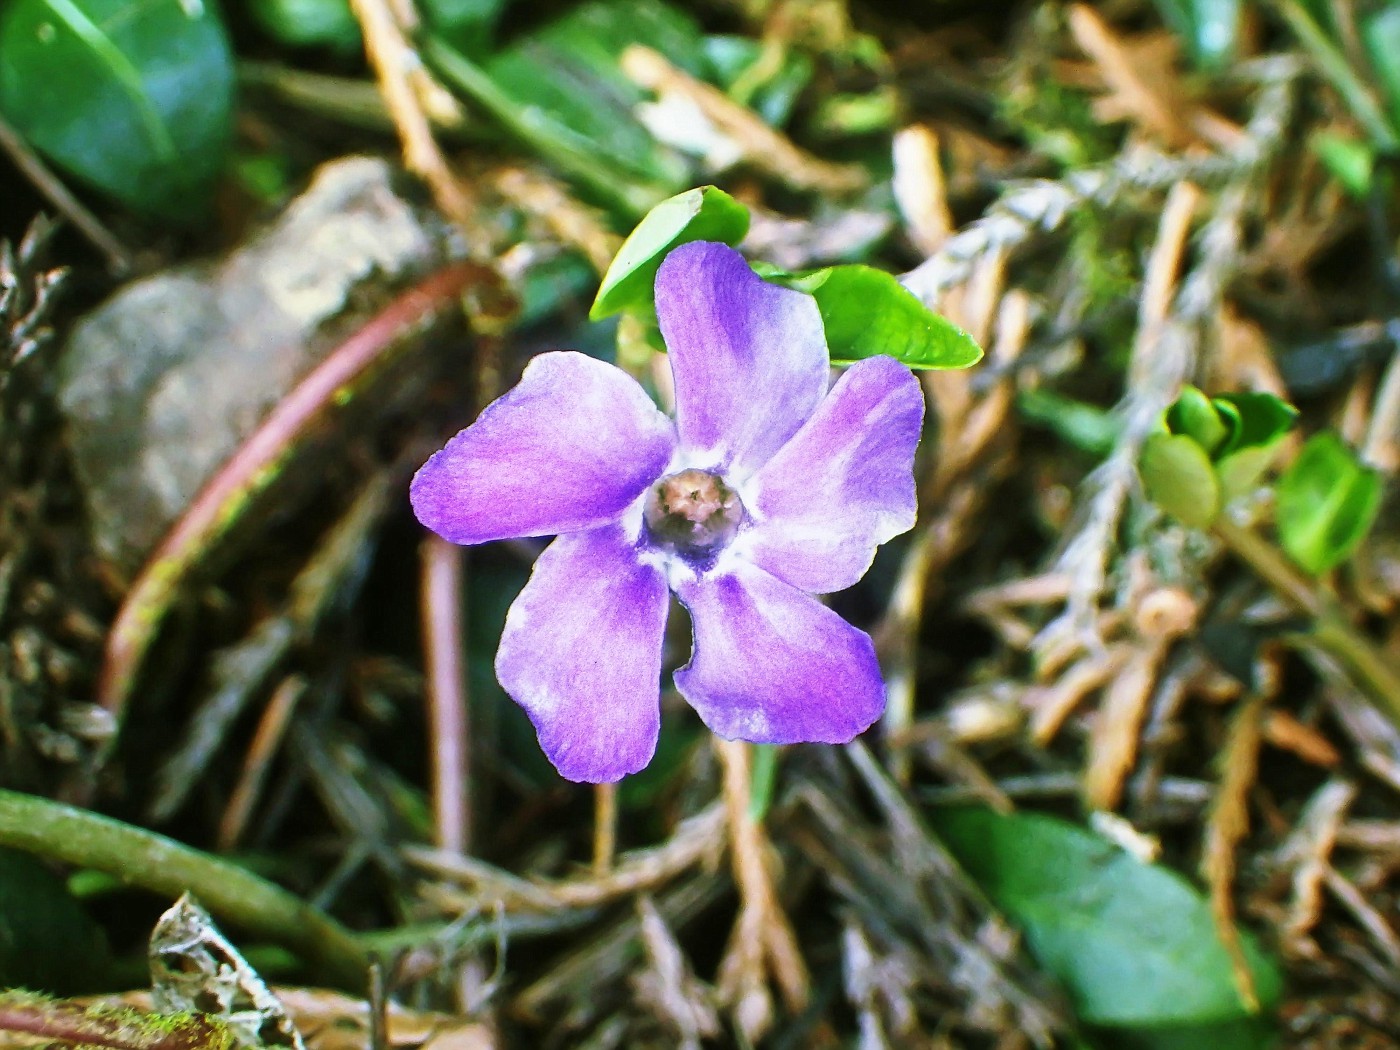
[412, 242, 924, 783]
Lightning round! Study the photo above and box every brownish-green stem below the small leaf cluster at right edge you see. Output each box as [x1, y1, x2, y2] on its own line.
[1212, 517, 1400, 725]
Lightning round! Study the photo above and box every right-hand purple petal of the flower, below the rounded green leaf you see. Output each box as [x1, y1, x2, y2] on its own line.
[743, 357, 924, 594]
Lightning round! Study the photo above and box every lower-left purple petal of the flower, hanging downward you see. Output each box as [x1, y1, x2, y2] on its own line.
[496, 525, 669, 784]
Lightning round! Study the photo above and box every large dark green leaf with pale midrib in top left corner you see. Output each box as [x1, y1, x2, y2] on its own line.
[0, 0, 234, 220]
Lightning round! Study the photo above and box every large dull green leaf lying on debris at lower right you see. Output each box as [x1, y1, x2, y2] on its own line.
[934, 808, 1282, 1030]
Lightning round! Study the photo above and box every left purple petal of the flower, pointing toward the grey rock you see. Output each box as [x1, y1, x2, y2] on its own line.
[409, 351, 676, 543]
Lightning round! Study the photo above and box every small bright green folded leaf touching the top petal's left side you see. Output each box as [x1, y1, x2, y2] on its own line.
[588, 186, 749, 321]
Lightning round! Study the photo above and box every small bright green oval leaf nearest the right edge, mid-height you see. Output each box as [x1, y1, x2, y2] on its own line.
[1277, 431, 1380, 575]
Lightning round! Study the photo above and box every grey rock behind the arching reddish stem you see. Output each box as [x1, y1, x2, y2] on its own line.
[59, 157, 444, 577]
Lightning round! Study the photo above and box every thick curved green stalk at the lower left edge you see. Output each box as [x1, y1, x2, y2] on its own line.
[0, 790, 370, 993]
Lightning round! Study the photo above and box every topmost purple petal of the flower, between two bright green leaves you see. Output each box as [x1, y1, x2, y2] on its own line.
[657, 241, 829, 477]
